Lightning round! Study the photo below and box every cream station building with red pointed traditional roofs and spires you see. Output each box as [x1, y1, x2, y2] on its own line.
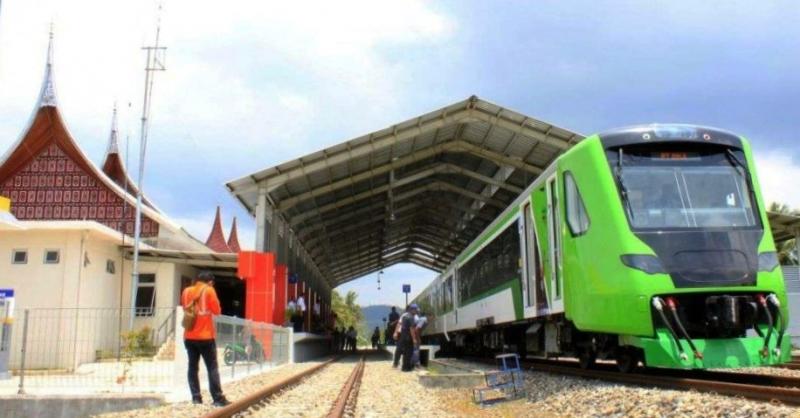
[0, 37, 244, 366]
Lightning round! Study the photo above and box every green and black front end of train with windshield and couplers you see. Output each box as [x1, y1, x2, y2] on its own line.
[600, 125, 791, 368]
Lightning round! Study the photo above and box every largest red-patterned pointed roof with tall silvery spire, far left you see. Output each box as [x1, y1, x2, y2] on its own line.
[0, 30, 212, 251]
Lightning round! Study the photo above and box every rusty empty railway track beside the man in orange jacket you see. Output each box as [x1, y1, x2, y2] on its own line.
[204, 355, 366, 418]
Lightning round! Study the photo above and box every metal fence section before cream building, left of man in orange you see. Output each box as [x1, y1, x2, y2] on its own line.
[11, 308, 175, 393]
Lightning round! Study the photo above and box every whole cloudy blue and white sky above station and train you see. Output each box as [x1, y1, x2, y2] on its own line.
[0, 0, 800, 305]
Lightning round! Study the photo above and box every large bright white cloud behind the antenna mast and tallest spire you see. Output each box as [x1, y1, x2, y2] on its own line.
[0, 0, 452, 162]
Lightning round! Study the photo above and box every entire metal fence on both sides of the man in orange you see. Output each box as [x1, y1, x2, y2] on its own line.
[7, 307, 292, 393]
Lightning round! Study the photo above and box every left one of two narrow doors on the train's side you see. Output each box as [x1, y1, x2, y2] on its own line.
[521, 202, 547, 317]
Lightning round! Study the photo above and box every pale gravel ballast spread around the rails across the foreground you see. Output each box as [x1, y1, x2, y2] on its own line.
[90, 355, 800, 418]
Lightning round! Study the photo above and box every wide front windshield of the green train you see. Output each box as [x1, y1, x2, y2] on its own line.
[609, 144, 759, 230]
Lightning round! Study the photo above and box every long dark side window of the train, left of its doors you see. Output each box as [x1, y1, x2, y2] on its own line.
[458, 222, 521, 305]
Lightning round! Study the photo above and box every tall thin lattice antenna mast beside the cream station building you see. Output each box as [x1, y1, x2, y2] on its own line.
[130, 3, 167, 330]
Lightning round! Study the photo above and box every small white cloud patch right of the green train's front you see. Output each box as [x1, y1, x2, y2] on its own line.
[755, 151, 800, 209]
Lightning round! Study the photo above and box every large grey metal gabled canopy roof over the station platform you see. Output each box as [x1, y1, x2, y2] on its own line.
[227, 96, 583, 287]
